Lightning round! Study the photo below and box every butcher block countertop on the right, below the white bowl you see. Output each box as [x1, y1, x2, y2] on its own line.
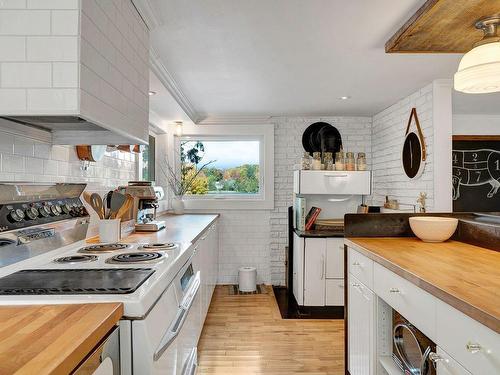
[346, 237, 500, 333]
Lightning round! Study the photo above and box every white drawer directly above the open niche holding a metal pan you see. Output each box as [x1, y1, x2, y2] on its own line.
[373, 263, 437, 340]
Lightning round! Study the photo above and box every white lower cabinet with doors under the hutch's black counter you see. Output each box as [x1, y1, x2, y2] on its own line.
[293, 234, 344, 306]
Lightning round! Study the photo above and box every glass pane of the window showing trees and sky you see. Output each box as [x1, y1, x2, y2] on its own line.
[179, 138, 262, 198]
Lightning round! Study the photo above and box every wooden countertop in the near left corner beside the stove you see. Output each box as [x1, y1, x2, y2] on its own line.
[0, 303, 123, 375]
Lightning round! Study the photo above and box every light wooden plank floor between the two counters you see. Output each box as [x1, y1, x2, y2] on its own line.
[198, 286, 344, 375]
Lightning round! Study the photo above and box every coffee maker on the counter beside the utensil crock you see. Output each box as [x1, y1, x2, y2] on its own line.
[119, 181, 165, 232]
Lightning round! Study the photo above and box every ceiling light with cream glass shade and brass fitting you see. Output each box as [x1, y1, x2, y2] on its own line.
[454, 15, 500, 94]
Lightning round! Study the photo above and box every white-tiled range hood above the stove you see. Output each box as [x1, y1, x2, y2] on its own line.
[0, 0, 149, 144]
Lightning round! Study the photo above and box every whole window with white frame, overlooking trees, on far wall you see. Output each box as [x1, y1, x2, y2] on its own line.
[169, 124, 274, 210]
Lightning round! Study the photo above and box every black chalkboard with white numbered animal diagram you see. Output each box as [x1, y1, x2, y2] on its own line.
[452, 136, 500, 212]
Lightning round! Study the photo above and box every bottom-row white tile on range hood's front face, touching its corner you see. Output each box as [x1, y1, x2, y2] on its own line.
[27, 89, 78, 114]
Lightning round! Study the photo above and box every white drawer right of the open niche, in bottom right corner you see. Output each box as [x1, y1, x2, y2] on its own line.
[436, 300, 500, 375]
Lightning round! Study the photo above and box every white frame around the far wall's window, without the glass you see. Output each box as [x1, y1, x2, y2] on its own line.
[169, 124, 274, 210]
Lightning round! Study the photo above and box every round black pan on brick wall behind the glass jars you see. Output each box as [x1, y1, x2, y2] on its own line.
[302, 122, 342, 154]
